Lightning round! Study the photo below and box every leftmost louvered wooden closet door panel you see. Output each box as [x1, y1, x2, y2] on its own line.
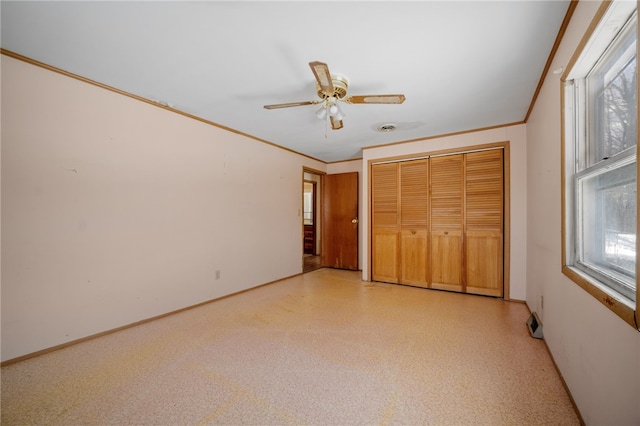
[371, 163, 400, 283]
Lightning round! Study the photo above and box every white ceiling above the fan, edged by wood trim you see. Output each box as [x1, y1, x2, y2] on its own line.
[0, 0, 569, 162]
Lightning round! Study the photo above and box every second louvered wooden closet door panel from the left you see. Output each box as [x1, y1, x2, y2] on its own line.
[400, 159, 429, 287]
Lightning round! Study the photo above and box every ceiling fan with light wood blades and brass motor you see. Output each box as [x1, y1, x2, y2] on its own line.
[264, 61, 405, 130]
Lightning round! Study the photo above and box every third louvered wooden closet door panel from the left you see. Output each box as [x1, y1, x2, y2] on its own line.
[430, 154, 464, 291]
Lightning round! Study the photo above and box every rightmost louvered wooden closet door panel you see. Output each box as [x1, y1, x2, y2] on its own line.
[465, 149, 504, 297]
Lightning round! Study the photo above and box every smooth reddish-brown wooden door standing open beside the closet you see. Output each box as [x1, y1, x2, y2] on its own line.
[322, 172, 358, 270]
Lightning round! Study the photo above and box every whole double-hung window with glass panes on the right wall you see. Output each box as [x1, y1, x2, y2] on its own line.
[563, 1, 638, 328]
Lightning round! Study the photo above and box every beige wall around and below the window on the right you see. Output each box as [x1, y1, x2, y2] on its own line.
[527, 2, 640, 425]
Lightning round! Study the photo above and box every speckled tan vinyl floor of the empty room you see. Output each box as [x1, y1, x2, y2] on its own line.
[1, 269, 579, 425]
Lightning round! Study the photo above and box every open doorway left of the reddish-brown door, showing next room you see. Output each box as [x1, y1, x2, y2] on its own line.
[302, 169, 323, 272]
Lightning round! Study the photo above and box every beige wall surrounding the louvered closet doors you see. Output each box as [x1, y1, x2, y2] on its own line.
[360, 125, 527, 300]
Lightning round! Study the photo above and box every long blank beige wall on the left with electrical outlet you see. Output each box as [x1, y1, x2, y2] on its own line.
[1, 55, 326, 360]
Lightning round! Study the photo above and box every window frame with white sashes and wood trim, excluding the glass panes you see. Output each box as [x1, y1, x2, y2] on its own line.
[561, 1, 640, 330]
